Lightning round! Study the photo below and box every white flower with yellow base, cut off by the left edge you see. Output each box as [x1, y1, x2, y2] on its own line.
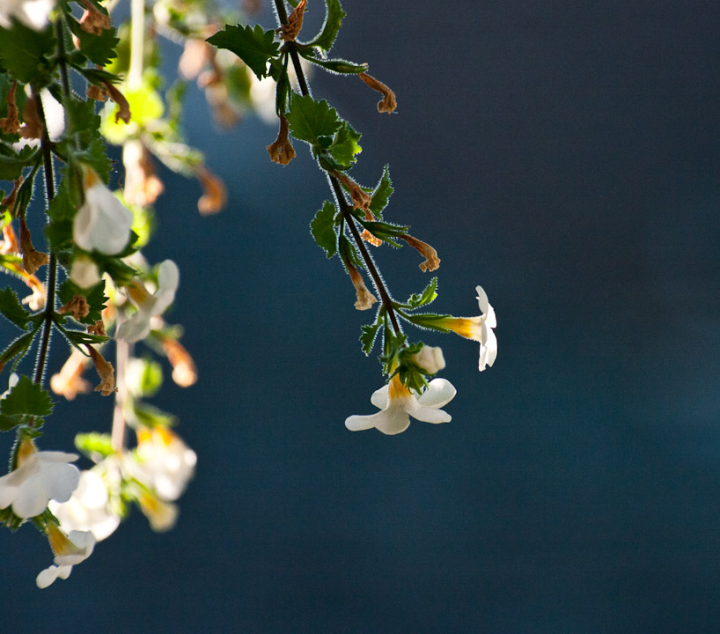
[0, 439, 80, 518]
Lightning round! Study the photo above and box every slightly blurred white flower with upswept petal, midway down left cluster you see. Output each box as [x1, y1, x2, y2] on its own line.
[115, 260, 180, 343]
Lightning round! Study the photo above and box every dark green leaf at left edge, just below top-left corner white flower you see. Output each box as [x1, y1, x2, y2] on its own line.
[0, 22, 55, 84]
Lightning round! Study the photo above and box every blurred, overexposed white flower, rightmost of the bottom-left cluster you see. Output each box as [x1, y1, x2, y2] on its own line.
[128, 427, 197, 502]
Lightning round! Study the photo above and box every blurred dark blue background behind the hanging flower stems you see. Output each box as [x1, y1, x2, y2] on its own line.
[0, 0, 720, 634]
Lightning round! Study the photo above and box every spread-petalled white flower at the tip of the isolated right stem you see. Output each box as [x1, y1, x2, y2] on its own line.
[345, 375, 456, 435]
